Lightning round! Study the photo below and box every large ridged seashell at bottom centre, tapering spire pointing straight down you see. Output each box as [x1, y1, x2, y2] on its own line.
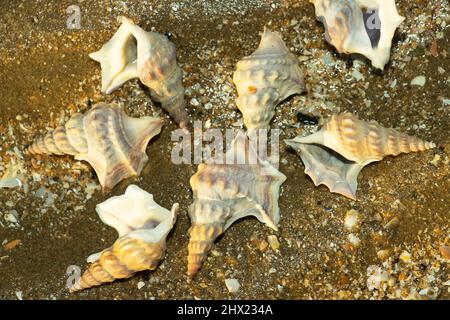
[188, 134, 286, 279]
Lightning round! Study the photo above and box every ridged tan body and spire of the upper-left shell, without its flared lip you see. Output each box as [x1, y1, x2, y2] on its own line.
[122, 17, 189, 128]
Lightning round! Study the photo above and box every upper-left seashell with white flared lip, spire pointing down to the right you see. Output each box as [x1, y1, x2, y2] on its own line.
[90, 17, 189, 128]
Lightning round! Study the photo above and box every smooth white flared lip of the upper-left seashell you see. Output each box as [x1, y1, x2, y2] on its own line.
[89, 17, 139, 94]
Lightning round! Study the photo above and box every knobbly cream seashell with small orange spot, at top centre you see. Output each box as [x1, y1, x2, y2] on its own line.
[233, 28, 305, 130]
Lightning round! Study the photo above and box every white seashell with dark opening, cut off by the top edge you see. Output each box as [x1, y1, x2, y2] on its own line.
[310, 0, 405, 69]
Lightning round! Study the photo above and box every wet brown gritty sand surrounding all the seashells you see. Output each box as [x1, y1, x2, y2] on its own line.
[0, 0, 450, 299]
